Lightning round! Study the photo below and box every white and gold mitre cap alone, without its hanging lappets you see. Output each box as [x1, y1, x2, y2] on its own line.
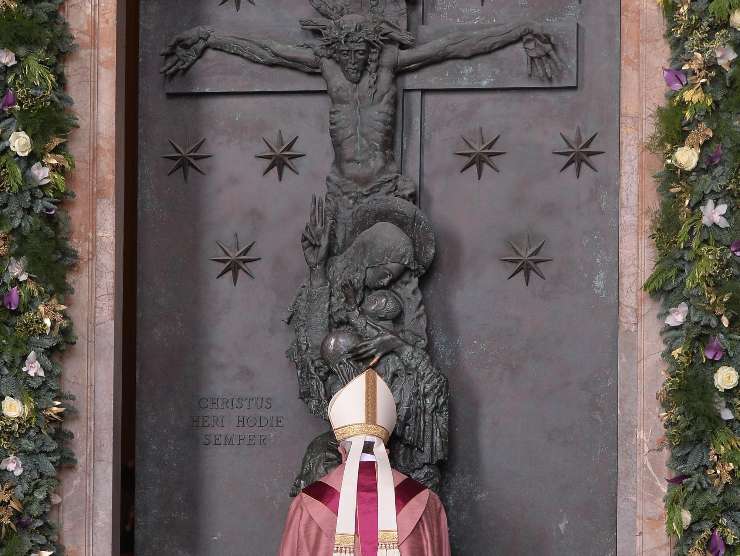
[329, 369, 396, 444]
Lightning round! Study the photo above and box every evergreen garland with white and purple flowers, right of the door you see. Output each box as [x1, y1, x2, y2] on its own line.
[645, 0, 740, 556]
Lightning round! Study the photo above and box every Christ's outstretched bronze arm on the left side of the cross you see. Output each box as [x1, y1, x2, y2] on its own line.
[161, 27, 320, 76]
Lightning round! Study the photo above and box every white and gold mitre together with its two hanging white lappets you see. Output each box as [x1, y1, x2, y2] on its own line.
[329, 368, 401, 556]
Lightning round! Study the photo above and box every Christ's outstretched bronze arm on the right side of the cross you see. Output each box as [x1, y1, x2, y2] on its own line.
[398, 23, 562, 79]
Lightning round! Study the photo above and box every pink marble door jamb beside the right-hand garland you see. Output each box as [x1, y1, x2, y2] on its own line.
[617, 0, 671, 556]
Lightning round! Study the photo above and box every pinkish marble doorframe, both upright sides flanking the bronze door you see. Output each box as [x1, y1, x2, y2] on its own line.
[58, 0, 670, 556]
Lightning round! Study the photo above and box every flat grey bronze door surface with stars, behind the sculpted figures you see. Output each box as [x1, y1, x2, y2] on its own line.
[136, 0, 619, 556]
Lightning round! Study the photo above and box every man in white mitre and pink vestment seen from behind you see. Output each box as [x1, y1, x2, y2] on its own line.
[279, 368, 450, 556]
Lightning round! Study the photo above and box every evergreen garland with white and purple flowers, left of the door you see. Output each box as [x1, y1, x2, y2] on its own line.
[0, 0, 75, 556]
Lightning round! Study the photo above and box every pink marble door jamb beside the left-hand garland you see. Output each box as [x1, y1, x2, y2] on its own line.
[59, 0, 123, 556]
